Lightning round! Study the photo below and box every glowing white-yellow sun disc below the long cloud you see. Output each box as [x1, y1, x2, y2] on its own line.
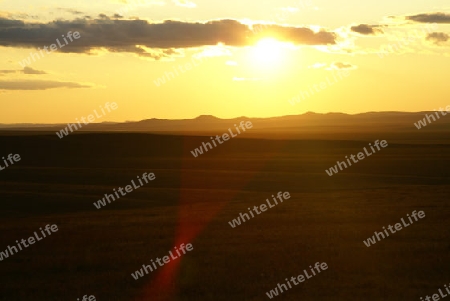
[252, 38, 283, 67]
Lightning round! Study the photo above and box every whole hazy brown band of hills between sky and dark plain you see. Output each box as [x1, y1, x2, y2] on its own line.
[0, 112, 450, 143]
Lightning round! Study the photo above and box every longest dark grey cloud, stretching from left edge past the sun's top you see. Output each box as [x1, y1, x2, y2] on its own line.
[0, 15, 337, 56]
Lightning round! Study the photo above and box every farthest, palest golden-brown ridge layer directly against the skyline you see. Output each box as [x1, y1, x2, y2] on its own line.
[0, 112, 450, 131]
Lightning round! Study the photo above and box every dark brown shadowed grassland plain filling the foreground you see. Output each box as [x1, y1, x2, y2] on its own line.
[0, 134, 450, 301]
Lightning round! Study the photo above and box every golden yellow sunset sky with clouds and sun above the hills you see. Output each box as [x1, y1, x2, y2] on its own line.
[0, 0, 450, 123]
